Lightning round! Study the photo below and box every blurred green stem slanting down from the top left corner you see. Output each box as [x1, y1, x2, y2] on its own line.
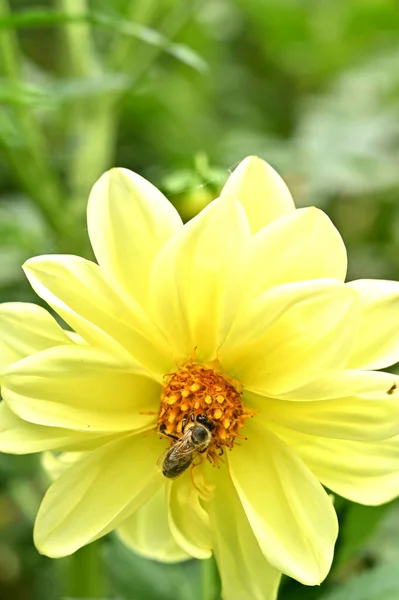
[0, 0, 68, 237]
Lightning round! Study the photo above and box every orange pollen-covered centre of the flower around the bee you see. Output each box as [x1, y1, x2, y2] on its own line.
[157, 358, 254, 465]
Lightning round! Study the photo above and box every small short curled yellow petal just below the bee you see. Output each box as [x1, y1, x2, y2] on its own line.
[168, 467, 212, 559]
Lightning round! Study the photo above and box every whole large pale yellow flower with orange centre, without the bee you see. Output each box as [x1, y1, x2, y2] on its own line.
[0, 157, 399, 600]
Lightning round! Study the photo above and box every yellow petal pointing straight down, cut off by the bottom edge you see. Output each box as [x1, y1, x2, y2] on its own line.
[204, 465, 281, 600]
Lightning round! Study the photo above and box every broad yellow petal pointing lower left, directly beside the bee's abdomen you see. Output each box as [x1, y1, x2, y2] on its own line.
[34, 434, 162, 558]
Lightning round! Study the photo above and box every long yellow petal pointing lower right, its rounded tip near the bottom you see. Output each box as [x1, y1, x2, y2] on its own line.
[228, 419, 338, 585]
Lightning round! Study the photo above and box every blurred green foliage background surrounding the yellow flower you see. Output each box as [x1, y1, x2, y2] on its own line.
[0, 0, 399, 600]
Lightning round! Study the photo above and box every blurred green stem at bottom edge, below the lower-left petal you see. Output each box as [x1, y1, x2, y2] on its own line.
[63, 540, 106, 600]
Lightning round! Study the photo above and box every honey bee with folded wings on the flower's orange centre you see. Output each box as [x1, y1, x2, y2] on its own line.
[158, 414, 215, 479]
